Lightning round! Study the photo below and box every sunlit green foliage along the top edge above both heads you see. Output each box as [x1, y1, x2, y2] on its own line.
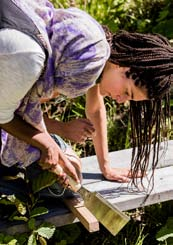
[52, 0, 173, 39]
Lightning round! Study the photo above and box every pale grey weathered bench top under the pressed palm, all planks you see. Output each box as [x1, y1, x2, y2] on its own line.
[82, 141, 173, 211]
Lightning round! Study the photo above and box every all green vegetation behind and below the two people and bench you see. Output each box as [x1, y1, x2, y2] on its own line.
[0, 0, 173, 245]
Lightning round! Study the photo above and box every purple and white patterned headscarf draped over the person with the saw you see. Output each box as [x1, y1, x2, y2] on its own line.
[1, 0, 110, 166]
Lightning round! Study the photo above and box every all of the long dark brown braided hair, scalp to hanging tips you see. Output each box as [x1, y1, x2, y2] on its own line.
[103, 27, 173, 189]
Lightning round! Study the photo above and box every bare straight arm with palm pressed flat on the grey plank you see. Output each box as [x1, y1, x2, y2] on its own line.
[86, 85, 130, 182]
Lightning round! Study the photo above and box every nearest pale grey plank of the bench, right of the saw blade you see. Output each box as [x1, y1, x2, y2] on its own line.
[107, 166, 173, 210]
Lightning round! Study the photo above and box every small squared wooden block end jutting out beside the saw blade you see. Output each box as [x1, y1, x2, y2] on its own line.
[63, 197, 99, 232]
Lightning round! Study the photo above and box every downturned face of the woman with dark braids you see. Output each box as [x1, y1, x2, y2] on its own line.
[99, 62, 148, 103]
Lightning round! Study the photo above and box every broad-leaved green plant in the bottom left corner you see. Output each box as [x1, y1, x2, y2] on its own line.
[0, 171, 56, 245]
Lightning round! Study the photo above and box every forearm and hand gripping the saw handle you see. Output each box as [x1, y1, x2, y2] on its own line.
[0, 115, 79, 182]
